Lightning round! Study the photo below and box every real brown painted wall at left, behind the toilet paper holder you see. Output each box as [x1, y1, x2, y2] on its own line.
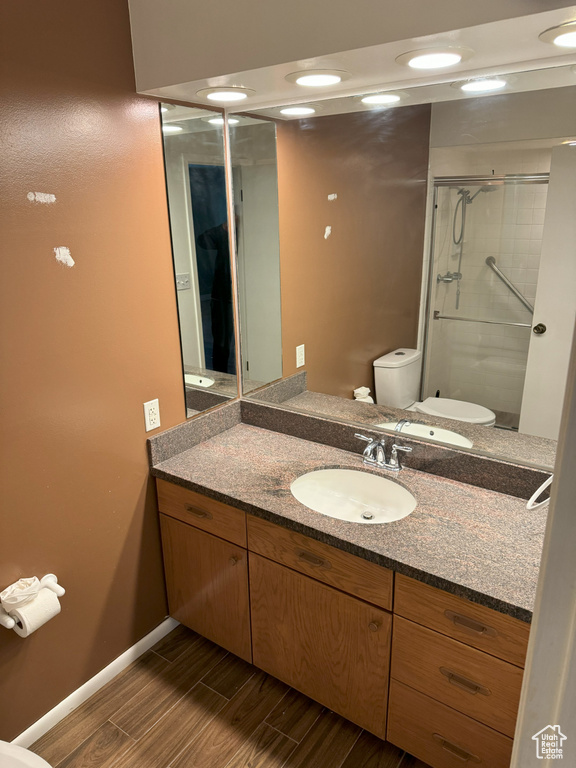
[0, 0, 185, 739]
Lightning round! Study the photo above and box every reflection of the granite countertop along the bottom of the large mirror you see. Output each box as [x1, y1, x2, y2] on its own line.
[282, 391, 556, 471]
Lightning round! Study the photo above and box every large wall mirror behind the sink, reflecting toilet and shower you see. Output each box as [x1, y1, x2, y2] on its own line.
[231, 66, 576, 467]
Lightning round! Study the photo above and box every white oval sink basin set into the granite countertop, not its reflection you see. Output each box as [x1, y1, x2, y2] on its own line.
[290, 469, 417, 523]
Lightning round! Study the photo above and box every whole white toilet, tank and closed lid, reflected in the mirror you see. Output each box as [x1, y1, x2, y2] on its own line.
[374, 348, 496, 427]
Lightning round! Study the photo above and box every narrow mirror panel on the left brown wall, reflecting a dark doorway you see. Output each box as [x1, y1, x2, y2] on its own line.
[160, 104, 238, 417]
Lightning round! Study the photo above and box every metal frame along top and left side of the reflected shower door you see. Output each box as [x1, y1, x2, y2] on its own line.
[420, 173, 550, 400]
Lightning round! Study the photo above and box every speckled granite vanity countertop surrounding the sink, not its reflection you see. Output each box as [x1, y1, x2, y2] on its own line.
[152, 424, 547, 621]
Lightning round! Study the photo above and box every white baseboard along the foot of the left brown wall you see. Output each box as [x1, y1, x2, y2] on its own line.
[12, 618, 179, 747]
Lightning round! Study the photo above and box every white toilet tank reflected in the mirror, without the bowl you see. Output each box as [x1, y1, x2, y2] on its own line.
[374, 348, 422, 408]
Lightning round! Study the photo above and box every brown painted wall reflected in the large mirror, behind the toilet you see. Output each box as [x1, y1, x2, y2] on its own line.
[278, 105, 430, 397]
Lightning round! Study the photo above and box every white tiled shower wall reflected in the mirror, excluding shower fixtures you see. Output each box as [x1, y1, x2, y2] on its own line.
[424, 147, 550, 414]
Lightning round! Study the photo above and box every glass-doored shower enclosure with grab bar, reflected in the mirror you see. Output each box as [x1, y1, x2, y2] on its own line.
[422, 174, 548, 429]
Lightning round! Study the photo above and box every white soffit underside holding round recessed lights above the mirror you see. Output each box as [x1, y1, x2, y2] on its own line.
[146, 6, 576, 117]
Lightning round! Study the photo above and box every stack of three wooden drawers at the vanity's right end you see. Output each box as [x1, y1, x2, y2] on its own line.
[387, 576, 529, 768]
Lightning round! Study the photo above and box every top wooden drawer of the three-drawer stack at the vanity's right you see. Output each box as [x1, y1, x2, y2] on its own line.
[394, 575, 530, 667]
